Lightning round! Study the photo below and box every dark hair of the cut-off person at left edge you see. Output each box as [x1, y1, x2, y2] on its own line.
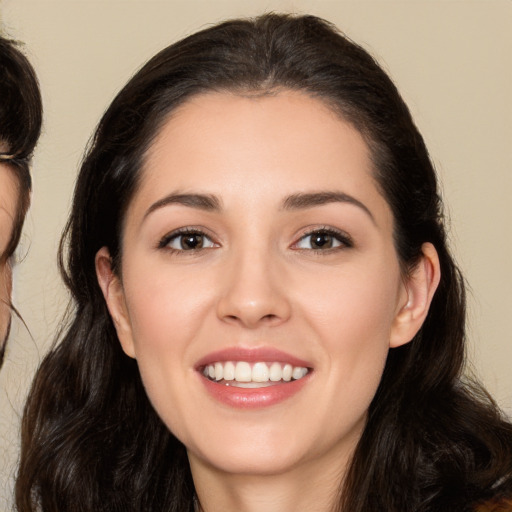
[0, 36, 43, 366]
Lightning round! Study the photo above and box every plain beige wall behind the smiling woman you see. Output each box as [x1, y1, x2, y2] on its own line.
[0, 0, 512, 510]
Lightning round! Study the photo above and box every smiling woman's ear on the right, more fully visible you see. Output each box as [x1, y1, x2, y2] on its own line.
[389, 243, 441, 348]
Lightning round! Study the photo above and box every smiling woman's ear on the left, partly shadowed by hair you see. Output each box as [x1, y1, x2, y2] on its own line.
[95, 247, 135, 359]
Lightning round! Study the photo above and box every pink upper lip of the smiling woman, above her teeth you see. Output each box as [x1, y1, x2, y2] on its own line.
[195, 347, 311, 369]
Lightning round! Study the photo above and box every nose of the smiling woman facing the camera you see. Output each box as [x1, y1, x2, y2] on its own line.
[217, 247, 291, 329]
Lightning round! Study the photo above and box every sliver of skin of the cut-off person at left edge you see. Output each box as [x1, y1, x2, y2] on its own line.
[0, 164, 18, 353]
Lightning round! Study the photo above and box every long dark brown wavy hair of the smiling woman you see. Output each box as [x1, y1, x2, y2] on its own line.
[16, 14, 512, 512]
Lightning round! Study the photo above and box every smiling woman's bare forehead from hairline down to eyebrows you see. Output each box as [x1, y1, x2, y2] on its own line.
[130, 90, 386, 226]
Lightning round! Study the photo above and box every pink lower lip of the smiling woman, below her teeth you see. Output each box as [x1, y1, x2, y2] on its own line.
[200, 373, 311, 409]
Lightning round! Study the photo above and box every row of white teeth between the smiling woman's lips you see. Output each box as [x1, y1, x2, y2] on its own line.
[202, 361, 310, 388]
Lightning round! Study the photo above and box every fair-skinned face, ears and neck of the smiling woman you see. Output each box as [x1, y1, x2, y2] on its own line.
[96, 91, 439, 512]
